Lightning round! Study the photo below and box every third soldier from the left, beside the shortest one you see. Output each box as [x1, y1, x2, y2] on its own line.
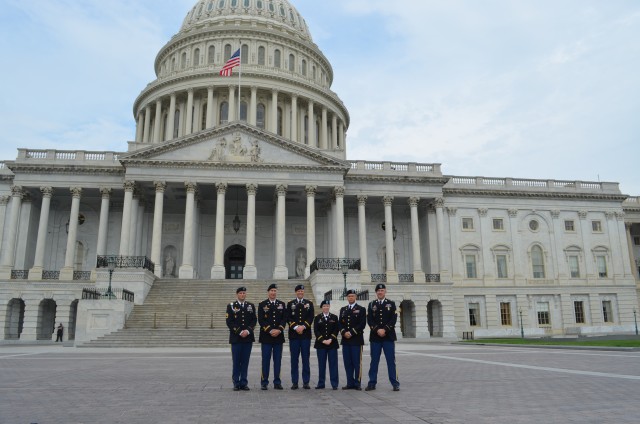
[287, 284, 313, 390]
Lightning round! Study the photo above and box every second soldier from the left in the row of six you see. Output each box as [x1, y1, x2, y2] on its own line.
[258, 284, 287, 390]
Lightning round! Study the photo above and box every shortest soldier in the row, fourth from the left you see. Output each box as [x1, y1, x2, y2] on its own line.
[313, 300, 340, 390]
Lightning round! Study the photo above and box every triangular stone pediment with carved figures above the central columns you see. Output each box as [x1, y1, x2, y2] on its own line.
[119, 123, 349, 170]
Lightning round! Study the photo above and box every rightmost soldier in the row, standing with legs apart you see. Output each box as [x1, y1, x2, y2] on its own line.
[365, 284, 400, 392]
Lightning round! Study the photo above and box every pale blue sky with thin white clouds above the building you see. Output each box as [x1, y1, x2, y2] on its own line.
[0, 0, 640, 196]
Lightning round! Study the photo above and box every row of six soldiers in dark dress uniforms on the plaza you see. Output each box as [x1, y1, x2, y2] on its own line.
[226, 284, 400, 391]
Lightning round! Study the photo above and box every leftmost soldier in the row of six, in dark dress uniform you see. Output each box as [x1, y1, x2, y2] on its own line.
[227, 287, 257, 391]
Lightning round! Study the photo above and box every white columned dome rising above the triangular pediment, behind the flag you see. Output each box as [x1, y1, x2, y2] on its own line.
[130, 0, 349, 159]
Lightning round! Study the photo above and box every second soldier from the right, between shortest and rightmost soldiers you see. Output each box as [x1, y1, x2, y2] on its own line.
[340, 290, 367, 390]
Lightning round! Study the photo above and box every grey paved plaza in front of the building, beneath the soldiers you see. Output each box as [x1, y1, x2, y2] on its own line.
[0, 342, 640, 424]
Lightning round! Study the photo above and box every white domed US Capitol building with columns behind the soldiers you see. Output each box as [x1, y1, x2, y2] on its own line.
[0, 0, 640, 345]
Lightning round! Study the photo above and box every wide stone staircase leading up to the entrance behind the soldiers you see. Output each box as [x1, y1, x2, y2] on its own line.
[79, 279, 304, 348]
